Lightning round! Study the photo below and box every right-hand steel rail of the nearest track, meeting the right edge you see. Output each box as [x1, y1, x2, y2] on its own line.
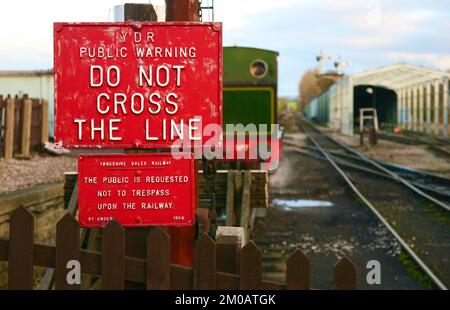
[303, 119, 450, 211]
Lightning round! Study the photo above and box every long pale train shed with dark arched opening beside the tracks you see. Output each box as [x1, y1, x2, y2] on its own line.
[304, 64, 450, 137]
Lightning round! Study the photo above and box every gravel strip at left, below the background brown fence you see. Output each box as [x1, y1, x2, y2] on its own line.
[0, 155, 77, 193]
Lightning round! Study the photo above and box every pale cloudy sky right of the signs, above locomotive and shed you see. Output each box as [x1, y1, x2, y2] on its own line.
[217, 0, 450, 95]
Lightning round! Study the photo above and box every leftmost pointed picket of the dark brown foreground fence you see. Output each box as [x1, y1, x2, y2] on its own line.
[8, 206, 34, 290]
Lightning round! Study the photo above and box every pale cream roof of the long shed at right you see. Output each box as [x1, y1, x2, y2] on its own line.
[351, 63, 450, 91]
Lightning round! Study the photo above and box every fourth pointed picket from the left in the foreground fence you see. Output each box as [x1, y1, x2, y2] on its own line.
[147, 227, 170, 290]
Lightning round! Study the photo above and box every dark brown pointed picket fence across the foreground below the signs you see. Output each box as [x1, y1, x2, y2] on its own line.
[0, 207, 356, 290]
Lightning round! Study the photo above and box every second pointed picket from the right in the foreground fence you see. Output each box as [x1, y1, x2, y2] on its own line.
[286, 249, 310, 290]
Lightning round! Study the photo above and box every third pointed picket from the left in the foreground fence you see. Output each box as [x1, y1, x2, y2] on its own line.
[101, 220, 125, 290]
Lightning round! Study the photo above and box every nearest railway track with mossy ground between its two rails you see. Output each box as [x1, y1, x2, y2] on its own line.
[301, 121, 450, 289]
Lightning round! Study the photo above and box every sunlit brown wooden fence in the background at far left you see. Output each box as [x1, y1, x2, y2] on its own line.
[0, 95, 50, 159]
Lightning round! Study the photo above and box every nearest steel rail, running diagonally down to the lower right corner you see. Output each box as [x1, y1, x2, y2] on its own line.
[299, 120, 448, 290]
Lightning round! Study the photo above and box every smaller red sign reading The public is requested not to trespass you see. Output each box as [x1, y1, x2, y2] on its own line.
[78, 153, 197, 227]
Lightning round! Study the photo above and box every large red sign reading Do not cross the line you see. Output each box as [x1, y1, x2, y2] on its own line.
[54, 22, 222, 148]
